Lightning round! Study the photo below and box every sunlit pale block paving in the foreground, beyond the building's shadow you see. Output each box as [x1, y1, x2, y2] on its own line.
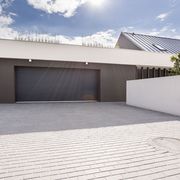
[0, 103, 180, 180]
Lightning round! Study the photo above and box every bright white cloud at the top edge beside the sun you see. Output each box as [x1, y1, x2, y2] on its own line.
[27, 0, 88, 17]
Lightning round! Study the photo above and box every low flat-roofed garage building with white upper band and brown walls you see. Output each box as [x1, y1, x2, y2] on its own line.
[0, 34, 177, 103]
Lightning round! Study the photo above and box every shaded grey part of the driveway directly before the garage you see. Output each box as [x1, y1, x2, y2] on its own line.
[0, 103, 180, 134]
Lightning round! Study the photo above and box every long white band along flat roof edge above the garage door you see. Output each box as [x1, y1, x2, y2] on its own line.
[0, 39, 173, 68]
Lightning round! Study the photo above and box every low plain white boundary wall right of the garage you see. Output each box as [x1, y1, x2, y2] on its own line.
[127, 76, 180, 116]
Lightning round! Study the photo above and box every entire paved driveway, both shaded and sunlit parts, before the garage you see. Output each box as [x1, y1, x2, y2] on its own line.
[0, 103, 180, 180]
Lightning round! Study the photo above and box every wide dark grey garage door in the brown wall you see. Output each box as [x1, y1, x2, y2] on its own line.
[15, 67, 99, 101]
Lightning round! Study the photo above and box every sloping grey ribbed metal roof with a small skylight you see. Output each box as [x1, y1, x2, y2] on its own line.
[122, 32, 180, 54]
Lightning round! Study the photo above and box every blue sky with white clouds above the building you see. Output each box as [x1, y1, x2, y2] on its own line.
[0, 0, 180, 47]
